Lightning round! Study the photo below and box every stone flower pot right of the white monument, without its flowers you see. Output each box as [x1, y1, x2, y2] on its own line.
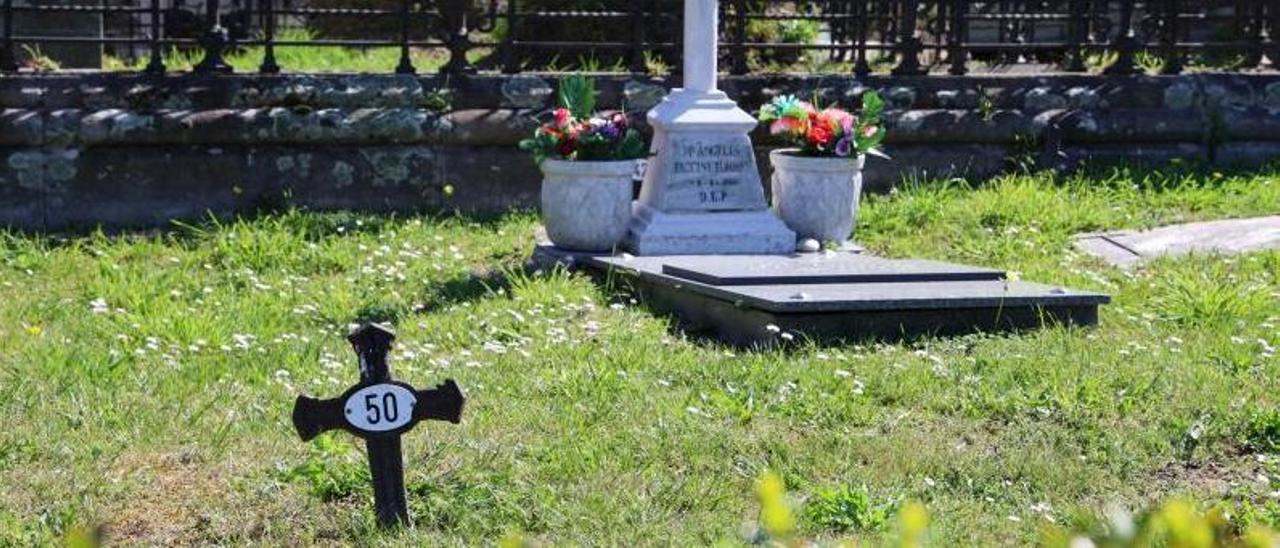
[769, 149, 865, 245]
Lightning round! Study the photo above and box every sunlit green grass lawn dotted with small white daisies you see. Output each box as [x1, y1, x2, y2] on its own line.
[0, 172, 1280, 545]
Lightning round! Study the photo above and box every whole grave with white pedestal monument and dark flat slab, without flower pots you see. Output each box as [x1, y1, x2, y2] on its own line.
[534, 0, 1110, 346]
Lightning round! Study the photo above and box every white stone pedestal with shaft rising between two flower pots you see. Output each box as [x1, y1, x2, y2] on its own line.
[627, 0, 796, 255]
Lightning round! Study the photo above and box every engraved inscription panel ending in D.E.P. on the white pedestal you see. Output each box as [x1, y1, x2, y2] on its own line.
[664, 134, 764, 211]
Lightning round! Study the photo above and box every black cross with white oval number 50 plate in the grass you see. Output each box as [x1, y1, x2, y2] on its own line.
[293, 324, 466, 528]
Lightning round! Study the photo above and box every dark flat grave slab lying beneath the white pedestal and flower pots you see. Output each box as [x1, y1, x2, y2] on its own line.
[524, 246, 1111, 346]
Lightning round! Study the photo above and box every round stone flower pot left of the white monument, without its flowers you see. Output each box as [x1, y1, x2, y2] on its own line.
[541, 159, 636, 251]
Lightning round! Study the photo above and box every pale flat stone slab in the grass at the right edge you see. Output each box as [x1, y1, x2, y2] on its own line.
[1075, 215, 1280, 266]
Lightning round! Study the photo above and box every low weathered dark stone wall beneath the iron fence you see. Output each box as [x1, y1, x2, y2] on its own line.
[0, 73, 1280, 229]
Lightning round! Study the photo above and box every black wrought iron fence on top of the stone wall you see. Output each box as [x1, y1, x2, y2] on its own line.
[0, 0, 1280, 76]
